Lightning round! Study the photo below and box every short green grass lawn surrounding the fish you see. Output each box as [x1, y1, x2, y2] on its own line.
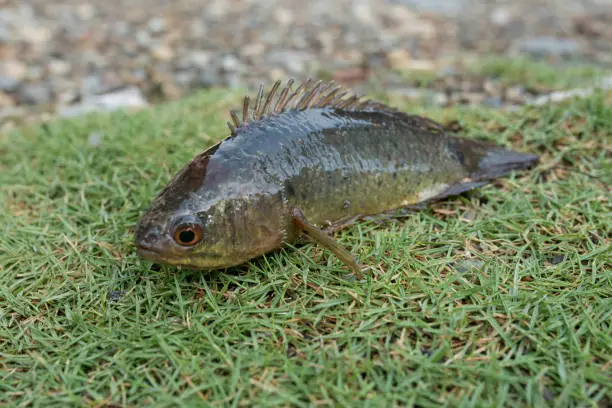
[0, 68, 612, 407]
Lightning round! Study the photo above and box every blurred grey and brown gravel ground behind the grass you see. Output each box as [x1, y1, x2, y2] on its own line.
[0, 0, 612, 121]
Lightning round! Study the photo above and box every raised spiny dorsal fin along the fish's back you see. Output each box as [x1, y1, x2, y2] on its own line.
[227, 79, 396, 135]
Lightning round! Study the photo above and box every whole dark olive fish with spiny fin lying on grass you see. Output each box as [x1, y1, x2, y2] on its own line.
[134, 79, 539, 277]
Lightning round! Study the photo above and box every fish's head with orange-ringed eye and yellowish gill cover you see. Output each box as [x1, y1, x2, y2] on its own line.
[134, 147, 285, 269]
